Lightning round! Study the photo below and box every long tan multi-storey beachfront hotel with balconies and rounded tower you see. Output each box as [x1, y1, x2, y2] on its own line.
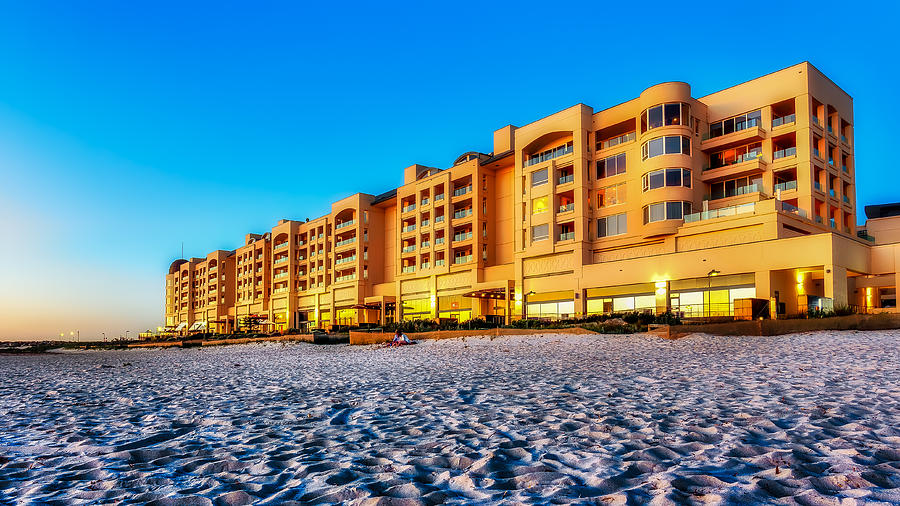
[165, 63, 900, 332]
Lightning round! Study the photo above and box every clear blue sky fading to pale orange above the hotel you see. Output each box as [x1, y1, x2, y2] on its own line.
[0, 0, 900, 339]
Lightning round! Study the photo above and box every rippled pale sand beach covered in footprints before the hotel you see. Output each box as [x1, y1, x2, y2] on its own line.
[0, 331, 900, 504]
